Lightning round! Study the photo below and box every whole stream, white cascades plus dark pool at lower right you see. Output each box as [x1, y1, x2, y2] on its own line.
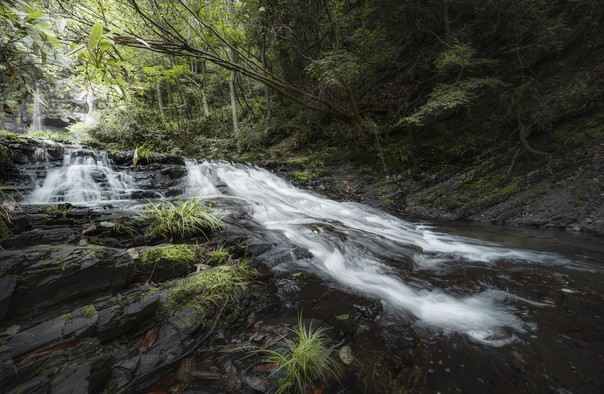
[5, 149, 604, 393]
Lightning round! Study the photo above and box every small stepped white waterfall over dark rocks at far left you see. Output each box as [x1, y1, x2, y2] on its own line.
[27, 149, 134, 204]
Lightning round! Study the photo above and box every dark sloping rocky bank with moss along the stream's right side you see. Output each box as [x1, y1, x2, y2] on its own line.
[257, 127, 604, 235]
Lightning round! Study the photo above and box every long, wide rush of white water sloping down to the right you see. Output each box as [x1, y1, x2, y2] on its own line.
[187, 162, 568, 346]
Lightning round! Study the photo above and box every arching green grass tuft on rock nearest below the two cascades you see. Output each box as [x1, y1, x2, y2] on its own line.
[141, 198, 222, 241]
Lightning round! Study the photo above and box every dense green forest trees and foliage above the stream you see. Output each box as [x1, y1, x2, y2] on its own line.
[0, 0, 604, 168]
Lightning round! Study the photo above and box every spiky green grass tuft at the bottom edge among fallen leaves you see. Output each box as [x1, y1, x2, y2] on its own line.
[262, 317, 342, 394]
